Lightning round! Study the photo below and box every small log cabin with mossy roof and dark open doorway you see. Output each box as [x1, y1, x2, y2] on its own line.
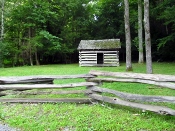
[78, 39, 121, 66]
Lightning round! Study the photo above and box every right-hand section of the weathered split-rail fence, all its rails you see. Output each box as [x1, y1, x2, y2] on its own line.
[87, 71, 175, 115]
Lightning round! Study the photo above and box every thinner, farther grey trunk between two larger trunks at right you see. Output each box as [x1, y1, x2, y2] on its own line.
[138, 0, 144, 63]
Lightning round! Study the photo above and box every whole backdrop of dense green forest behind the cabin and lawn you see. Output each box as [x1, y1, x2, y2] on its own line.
[0, 0, 175, 66]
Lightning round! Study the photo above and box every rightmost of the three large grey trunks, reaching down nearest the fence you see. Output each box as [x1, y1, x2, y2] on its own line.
[144, 0, 153, 74]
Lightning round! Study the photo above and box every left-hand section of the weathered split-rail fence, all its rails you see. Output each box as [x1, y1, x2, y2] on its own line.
[0, 74, 95, 103]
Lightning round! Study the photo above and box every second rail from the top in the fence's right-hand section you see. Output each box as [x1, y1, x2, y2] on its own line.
[87, 78, 175, 90]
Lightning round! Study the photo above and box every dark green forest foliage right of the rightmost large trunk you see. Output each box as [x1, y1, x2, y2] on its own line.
[152, 0, 175, 61]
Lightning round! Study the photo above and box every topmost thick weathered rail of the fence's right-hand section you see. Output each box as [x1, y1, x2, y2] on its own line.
[89, 70, 175, 82]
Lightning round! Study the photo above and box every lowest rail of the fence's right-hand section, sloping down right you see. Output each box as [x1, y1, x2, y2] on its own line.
[89, 94, 175, 116]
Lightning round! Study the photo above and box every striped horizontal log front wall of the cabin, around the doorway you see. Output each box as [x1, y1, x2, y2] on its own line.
[79, 51, 119, 66]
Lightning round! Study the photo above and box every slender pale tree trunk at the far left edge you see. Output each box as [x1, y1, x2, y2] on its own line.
[0, 0, 5, 67]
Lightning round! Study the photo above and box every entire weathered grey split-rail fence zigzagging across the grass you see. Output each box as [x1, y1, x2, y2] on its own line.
[0, 71, 175, 116]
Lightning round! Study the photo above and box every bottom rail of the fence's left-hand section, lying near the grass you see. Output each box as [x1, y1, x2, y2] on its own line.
[0, 98, 94, 104]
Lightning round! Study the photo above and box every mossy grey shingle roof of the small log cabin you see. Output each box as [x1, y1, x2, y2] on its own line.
[78, 39, 121, 50]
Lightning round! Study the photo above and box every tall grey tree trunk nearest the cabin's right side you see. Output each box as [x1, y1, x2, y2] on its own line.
[124, 0, 132, 71]
